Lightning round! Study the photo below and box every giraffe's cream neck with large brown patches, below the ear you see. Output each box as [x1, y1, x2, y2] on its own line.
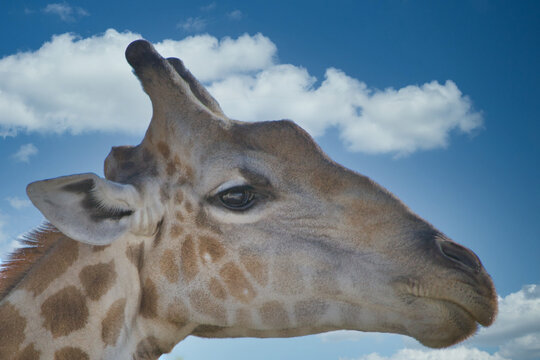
[0, 233, 194, 360]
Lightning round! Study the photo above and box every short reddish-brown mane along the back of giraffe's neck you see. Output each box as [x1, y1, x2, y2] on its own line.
[0, 222, 62, 300]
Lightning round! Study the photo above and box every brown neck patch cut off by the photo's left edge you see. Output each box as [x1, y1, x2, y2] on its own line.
[0, 303, 26, 359]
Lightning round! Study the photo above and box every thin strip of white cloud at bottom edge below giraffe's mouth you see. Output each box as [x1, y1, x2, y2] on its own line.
[348, 346, 511, 360]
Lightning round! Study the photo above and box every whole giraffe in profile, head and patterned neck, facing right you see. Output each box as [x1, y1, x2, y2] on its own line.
[0, 40, 497, 360]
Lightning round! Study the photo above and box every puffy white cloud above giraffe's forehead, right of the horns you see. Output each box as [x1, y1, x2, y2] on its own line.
[210, 65, 482, 154]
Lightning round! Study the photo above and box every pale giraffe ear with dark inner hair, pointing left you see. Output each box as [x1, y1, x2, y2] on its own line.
[26, 173, 141, 245]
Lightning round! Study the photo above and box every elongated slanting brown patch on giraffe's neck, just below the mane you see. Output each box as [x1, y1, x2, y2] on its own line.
[24, 237, 79, 296]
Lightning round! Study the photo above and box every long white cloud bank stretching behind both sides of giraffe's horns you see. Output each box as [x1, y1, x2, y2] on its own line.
[0, 28, 482, 155]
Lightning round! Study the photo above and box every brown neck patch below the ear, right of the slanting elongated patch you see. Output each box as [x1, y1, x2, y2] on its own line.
[79, 260, 116, 300]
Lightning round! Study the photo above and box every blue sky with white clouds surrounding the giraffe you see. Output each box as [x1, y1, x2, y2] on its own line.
[0, 0, 540, 360]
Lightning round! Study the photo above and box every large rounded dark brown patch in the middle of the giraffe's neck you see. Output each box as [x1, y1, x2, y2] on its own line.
[41, 286, 88, 338]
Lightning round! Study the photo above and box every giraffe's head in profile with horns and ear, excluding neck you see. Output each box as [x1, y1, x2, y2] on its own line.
[28, 40, 497, 347]
